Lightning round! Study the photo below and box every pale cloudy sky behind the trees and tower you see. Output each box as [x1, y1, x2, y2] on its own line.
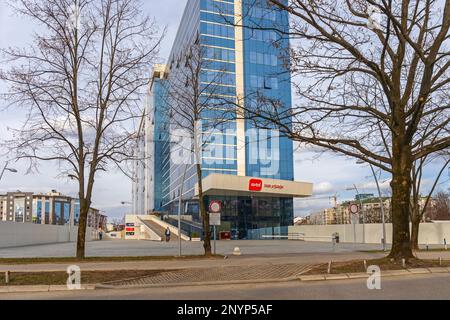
[0, 0, 448, 217]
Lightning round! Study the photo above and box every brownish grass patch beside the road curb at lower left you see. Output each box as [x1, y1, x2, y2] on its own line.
[0, 270, 172, 287]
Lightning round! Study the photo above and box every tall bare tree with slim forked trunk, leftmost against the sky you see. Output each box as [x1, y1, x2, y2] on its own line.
[0, 0, 161, 259]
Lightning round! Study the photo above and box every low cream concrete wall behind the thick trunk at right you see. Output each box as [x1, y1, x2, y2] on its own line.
[289, 221, 450, 244]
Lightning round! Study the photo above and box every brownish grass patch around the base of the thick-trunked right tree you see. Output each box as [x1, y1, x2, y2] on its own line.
[306, 258, 450, 275]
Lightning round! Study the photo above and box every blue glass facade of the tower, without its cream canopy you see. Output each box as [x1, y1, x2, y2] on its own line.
[153, 0, 294, 238]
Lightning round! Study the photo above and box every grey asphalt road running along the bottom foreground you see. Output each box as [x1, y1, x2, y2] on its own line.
[0, 274, 450, 300]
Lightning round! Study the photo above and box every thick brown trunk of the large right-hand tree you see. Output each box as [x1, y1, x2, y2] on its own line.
[389, 140, 414, 260]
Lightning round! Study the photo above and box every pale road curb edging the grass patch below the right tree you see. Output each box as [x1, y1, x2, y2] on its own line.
[297, 267, 450, 282]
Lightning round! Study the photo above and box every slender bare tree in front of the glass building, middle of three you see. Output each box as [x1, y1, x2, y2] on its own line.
[166, 42, 235, 255]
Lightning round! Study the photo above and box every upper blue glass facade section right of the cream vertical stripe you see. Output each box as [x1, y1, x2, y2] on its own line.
[243, 0, 294, 181]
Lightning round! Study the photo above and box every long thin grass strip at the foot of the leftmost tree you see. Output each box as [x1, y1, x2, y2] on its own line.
[0, 255, 224, 265]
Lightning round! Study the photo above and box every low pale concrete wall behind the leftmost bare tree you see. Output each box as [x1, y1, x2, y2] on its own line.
[0, 221, 94, 248]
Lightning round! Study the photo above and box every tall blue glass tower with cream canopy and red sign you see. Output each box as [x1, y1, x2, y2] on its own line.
[133, 0, 312, 238]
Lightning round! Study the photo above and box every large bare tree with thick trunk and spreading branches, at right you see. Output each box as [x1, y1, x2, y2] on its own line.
[236, 0, 450, 259]
